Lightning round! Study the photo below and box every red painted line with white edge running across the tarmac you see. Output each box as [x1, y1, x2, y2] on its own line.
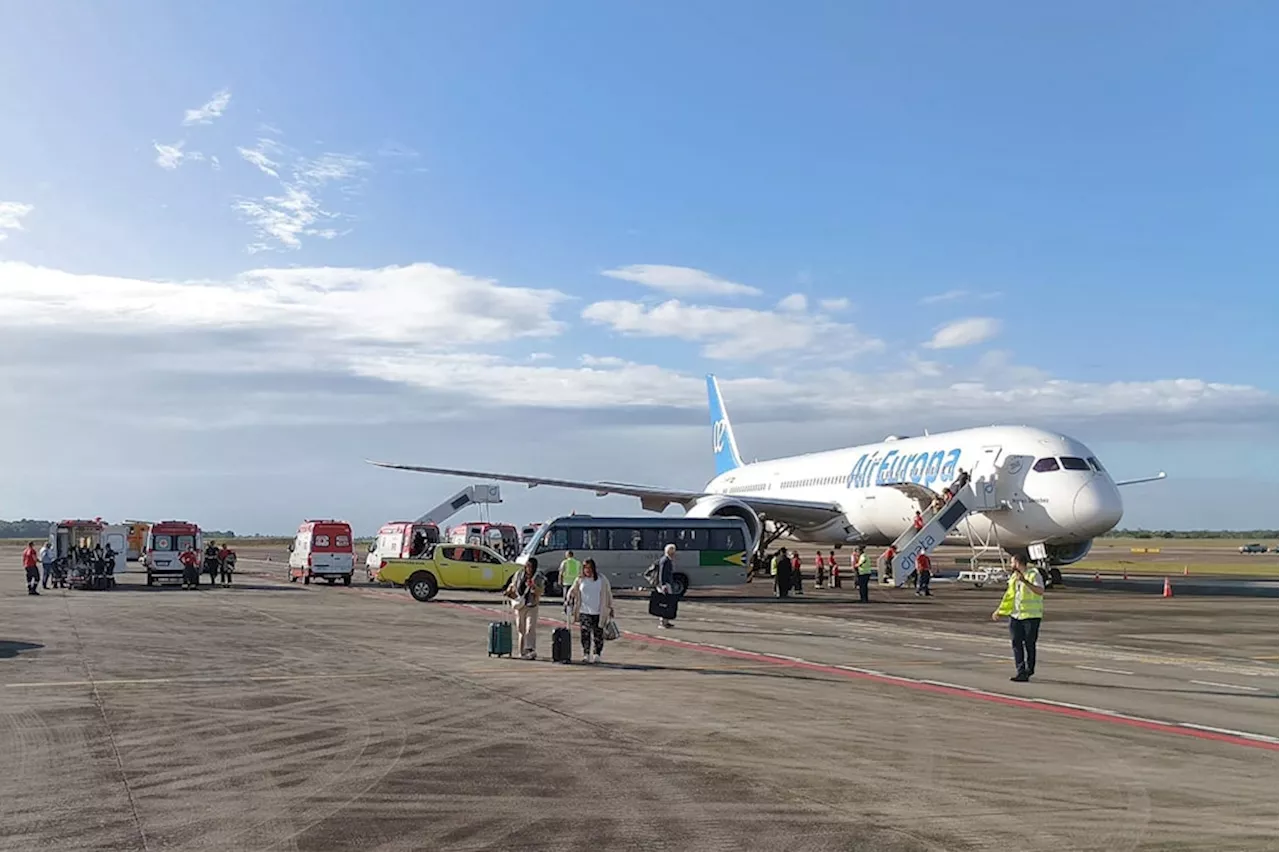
[435, 601, 1280, 751]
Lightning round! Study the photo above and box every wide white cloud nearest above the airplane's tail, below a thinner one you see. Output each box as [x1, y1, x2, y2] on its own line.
[582, 299, 883, 359]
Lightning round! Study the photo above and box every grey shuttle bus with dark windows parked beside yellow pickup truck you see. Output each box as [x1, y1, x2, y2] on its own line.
[516, 514, 756, 595]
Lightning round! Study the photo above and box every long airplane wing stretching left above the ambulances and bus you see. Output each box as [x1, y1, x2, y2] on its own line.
[369, 461, 845, 526]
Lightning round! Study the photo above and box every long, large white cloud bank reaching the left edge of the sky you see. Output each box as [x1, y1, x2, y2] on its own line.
[0, 262, 567, 345]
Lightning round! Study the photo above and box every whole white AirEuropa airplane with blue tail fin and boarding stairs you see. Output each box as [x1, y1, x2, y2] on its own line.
[369, 375, 1165, 585]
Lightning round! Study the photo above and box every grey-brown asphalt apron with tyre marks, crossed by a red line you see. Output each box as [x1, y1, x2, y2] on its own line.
[0, 551, 1280, 851]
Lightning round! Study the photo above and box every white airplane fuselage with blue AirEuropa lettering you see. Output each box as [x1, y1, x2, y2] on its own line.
[707, 426, 1123, 548]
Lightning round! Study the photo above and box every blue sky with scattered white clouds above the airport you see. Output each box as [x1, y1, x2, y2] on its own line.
[0, 1, 1280, 530]
